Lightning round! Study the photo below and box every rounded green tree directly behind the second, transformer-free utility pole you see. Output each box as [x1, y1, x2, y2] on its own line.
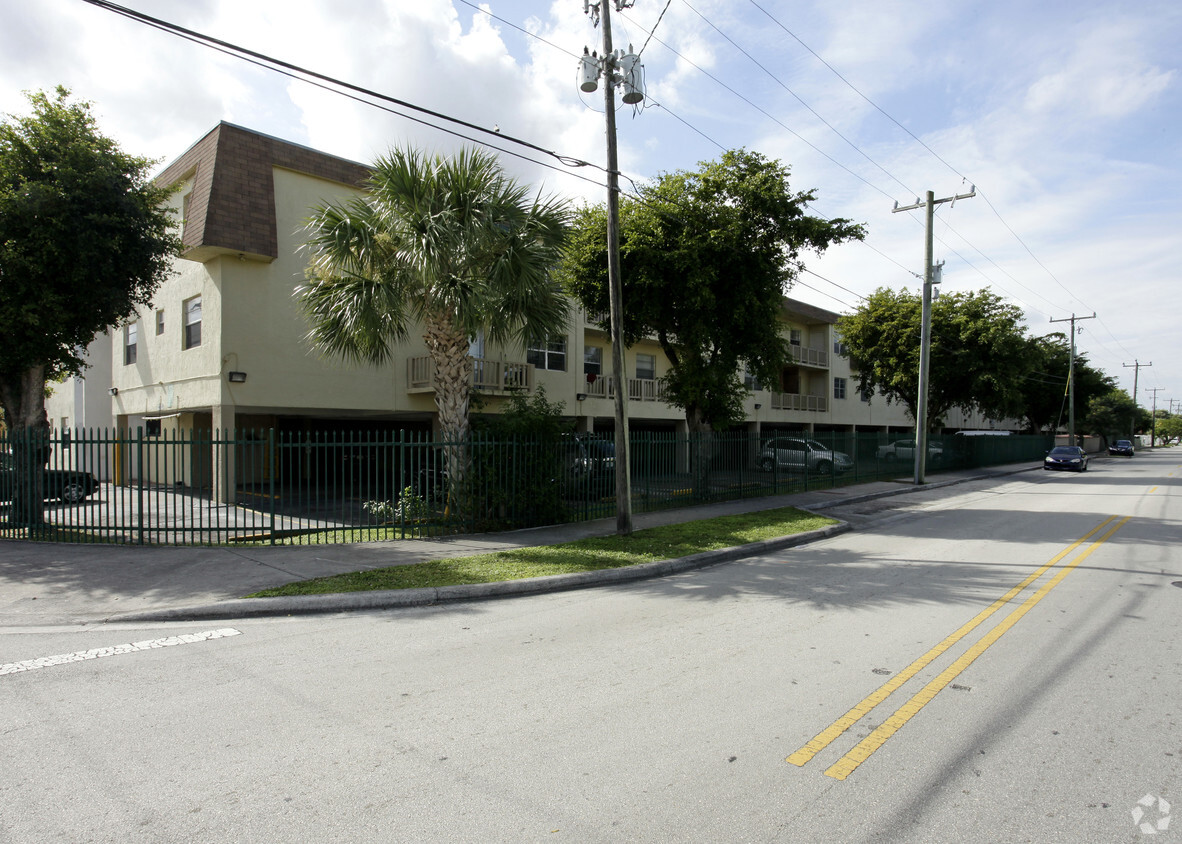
[838, 287, 1030, 427]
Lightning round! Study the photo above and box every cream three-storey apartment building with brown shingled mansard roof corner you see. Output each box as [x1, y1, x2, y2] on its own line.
[48, 123, 987, 479]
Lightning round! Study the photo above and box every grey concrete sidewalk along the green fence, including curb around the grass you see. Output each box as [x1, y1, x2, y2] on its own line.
[0, 463, 1039, 628]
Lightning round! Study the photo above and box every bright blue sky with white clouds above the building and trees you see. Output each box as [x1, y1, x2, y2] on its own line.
[0, 0, 1182, 410]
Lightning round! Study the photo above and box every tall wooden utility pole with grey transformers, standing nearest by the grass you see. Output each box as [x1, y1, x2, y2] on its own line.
[579, 0, 644, 535]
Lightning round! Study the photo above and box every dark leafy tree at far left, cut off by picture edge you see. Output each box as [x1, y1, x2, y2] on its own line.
[0, 87, 180, 524]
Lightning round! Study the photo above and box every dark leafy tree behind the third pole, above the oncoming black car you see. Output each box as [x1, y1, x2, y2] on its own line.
[1021, 332, 1116, 433]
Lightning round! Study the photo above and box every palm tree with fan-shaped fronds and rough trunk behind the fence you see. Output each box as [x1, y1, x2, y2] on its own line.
[296, 148, 571, 494]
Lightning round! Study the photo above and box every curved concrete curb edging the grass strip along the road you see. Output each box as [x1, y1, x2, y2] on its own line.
[104, 515, 851, 622]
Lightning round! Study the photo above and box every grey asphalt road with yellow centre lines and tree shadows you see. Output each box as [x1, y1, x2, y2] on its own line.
[0, 450, 1182, 843]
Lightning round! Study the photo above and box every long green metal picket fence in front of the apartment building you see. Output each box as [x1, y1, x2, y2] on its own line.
[0, 429, 1053, 545]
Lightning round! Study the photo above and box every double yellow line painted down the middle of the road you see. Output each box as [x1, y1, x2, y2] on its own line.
[787, 515, 1131, 779]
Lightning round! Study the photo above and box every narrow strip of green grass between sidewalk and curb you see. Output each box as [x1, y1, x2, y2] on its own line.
[246, 507, 836, 598]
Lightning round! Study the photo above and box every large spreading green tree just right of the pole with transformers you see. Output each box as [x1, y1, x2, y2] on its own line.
[560, 150, 863, 434]
